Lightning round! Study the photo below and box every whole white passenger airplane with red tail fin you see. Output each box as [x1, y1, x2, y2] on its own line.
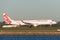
[3, 13, 57, 27]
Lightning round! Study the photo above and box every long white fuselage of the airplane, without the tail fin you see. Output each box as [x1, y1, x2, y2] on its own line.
[12, 20, 57, 26]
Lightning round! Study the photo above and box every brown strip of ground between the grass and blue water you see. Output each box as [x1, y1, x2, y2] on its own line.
[0, 30, 60, 36]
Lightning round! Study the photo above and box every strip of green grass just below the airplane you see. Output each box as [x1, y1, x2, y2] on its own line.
[0, 27, 60, 31]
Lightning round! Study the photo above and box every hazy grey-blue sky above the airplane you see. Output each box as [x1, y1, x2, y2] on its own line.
[0, 0, 60, 21]
